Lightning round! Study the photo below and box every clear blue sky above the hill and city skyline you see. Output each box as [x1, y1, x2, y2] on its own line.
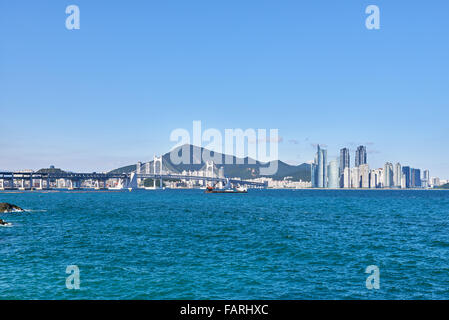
[0, 0, 449, 178]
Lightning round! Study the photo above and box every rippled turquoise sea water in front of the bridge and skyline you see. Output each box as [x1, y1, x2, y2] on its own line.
[0, 190, 449, 299]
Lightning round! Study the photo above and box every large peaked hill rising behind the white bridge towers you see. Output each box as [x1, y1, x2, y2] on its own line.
[110, 145, 310, 181]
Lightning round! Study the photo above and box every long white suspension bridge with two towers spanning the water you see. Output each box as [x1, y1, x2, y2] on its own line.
[0, 156, 267, 190]
